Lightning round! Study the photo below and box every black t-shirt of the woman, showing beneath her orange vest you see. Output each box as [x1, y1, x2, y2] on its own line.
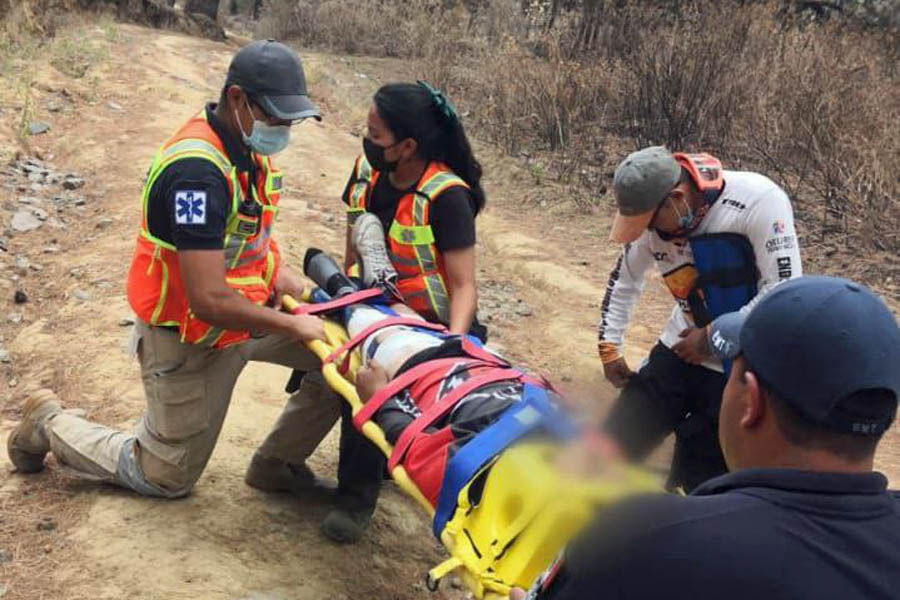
[342, 170, 478, 252]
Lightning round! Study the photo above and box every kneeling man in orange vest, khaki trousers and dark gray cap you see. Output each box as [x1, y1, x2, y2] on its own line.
[7, 40, 380, 524]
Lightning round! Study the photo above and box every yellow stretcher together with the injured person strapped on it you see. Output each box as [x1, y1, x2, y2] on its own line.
[286, 250, 660, 598]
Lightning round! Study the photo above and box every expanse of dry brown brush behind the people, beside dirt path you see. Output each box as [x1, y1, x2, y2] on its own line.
[260, 0, 900, 297]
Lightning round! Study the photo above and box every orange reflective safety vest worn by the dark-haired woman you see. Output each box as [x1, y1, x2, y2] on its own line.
[347, 155, 469, 324]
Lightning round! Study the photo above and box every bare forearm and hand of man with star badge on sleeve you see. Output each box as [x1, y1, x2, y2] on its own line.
[178, 250, 325, 341]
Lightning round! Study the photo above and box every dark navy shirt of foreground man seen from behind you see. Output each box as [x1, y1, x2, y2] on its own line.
[537, 469, 900, 600]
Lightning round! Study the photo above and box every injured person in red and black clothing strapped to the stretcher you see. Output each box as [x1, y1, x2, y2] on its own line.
[310, 255, 558, 506]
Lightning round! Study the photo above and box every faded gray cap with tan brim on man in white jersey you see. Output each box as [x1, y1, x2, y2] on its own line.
[609, 146, 681, 244]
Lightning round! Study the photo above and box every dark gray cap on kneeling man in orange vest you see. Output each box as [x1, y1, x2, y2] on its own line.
[225, 40, 322, 121]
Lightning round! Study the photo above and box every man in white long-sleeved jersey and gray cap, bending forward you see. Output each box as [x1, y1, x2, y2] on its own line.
[599, 146, 801, 491]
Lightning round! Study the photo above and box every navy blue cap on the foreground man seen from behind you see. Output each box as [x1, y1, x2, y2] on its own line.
[709, 276, 900, 434]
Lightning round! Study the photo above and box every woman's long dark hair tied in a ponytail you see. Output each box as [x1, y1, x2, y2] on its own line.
[375, 83, 486, 214]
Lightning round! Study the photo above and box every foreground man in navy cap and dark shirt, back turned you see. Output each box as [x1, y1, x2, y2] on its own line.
[511, 277, 900, 600]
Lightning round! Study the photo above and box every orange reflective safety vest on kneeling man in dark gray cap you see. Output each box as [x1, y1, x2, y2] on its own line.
[127, 110, 281, 348]
